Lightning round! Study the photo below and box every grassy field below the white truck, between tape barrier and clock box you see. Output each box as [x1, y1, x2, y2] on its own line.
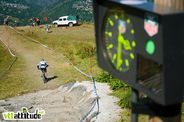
[18, 24, 101, 76]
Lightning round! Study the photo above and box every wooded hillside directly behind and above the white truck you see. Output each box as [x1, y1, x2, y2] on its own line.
[40, 0, 93, 21]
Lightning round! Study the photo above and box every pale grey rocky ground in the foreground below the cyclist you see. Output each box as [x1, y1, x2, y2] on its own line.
[0, 81, 121, 122]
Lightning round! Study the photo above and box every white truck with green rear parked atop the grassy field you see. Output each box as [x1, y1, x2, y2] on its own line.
[52, 16, 78, 27]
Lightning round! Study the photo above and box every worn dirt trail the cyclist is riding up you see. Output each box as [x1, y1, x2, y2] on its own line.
[0, 26, 82, 89]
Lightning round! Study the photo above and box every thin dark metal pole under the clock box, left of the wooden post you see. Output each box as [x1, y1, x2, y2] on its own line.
[131, 88, 139, 122]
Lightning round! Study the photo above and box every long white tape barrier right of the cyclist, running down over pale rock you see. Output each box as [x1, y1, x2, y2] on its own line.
[9, 26, 100, 122]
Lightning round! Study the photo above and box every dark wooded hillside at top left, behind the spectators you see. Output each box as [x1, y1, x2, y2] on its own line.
[0, 0, 40, 25]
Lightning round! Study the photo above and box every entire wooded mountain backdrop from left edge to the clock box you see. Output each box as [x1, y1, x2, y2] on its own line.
[0, 0, 92, 25]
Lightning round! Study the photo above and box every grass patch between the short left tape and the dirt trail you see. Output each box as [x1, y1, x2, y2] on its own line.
[0, 55, 29, 99]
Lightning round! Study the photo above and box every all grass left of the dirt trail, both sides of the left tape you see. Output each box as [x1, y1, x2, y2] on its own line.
[0, 42, 27, 99]
